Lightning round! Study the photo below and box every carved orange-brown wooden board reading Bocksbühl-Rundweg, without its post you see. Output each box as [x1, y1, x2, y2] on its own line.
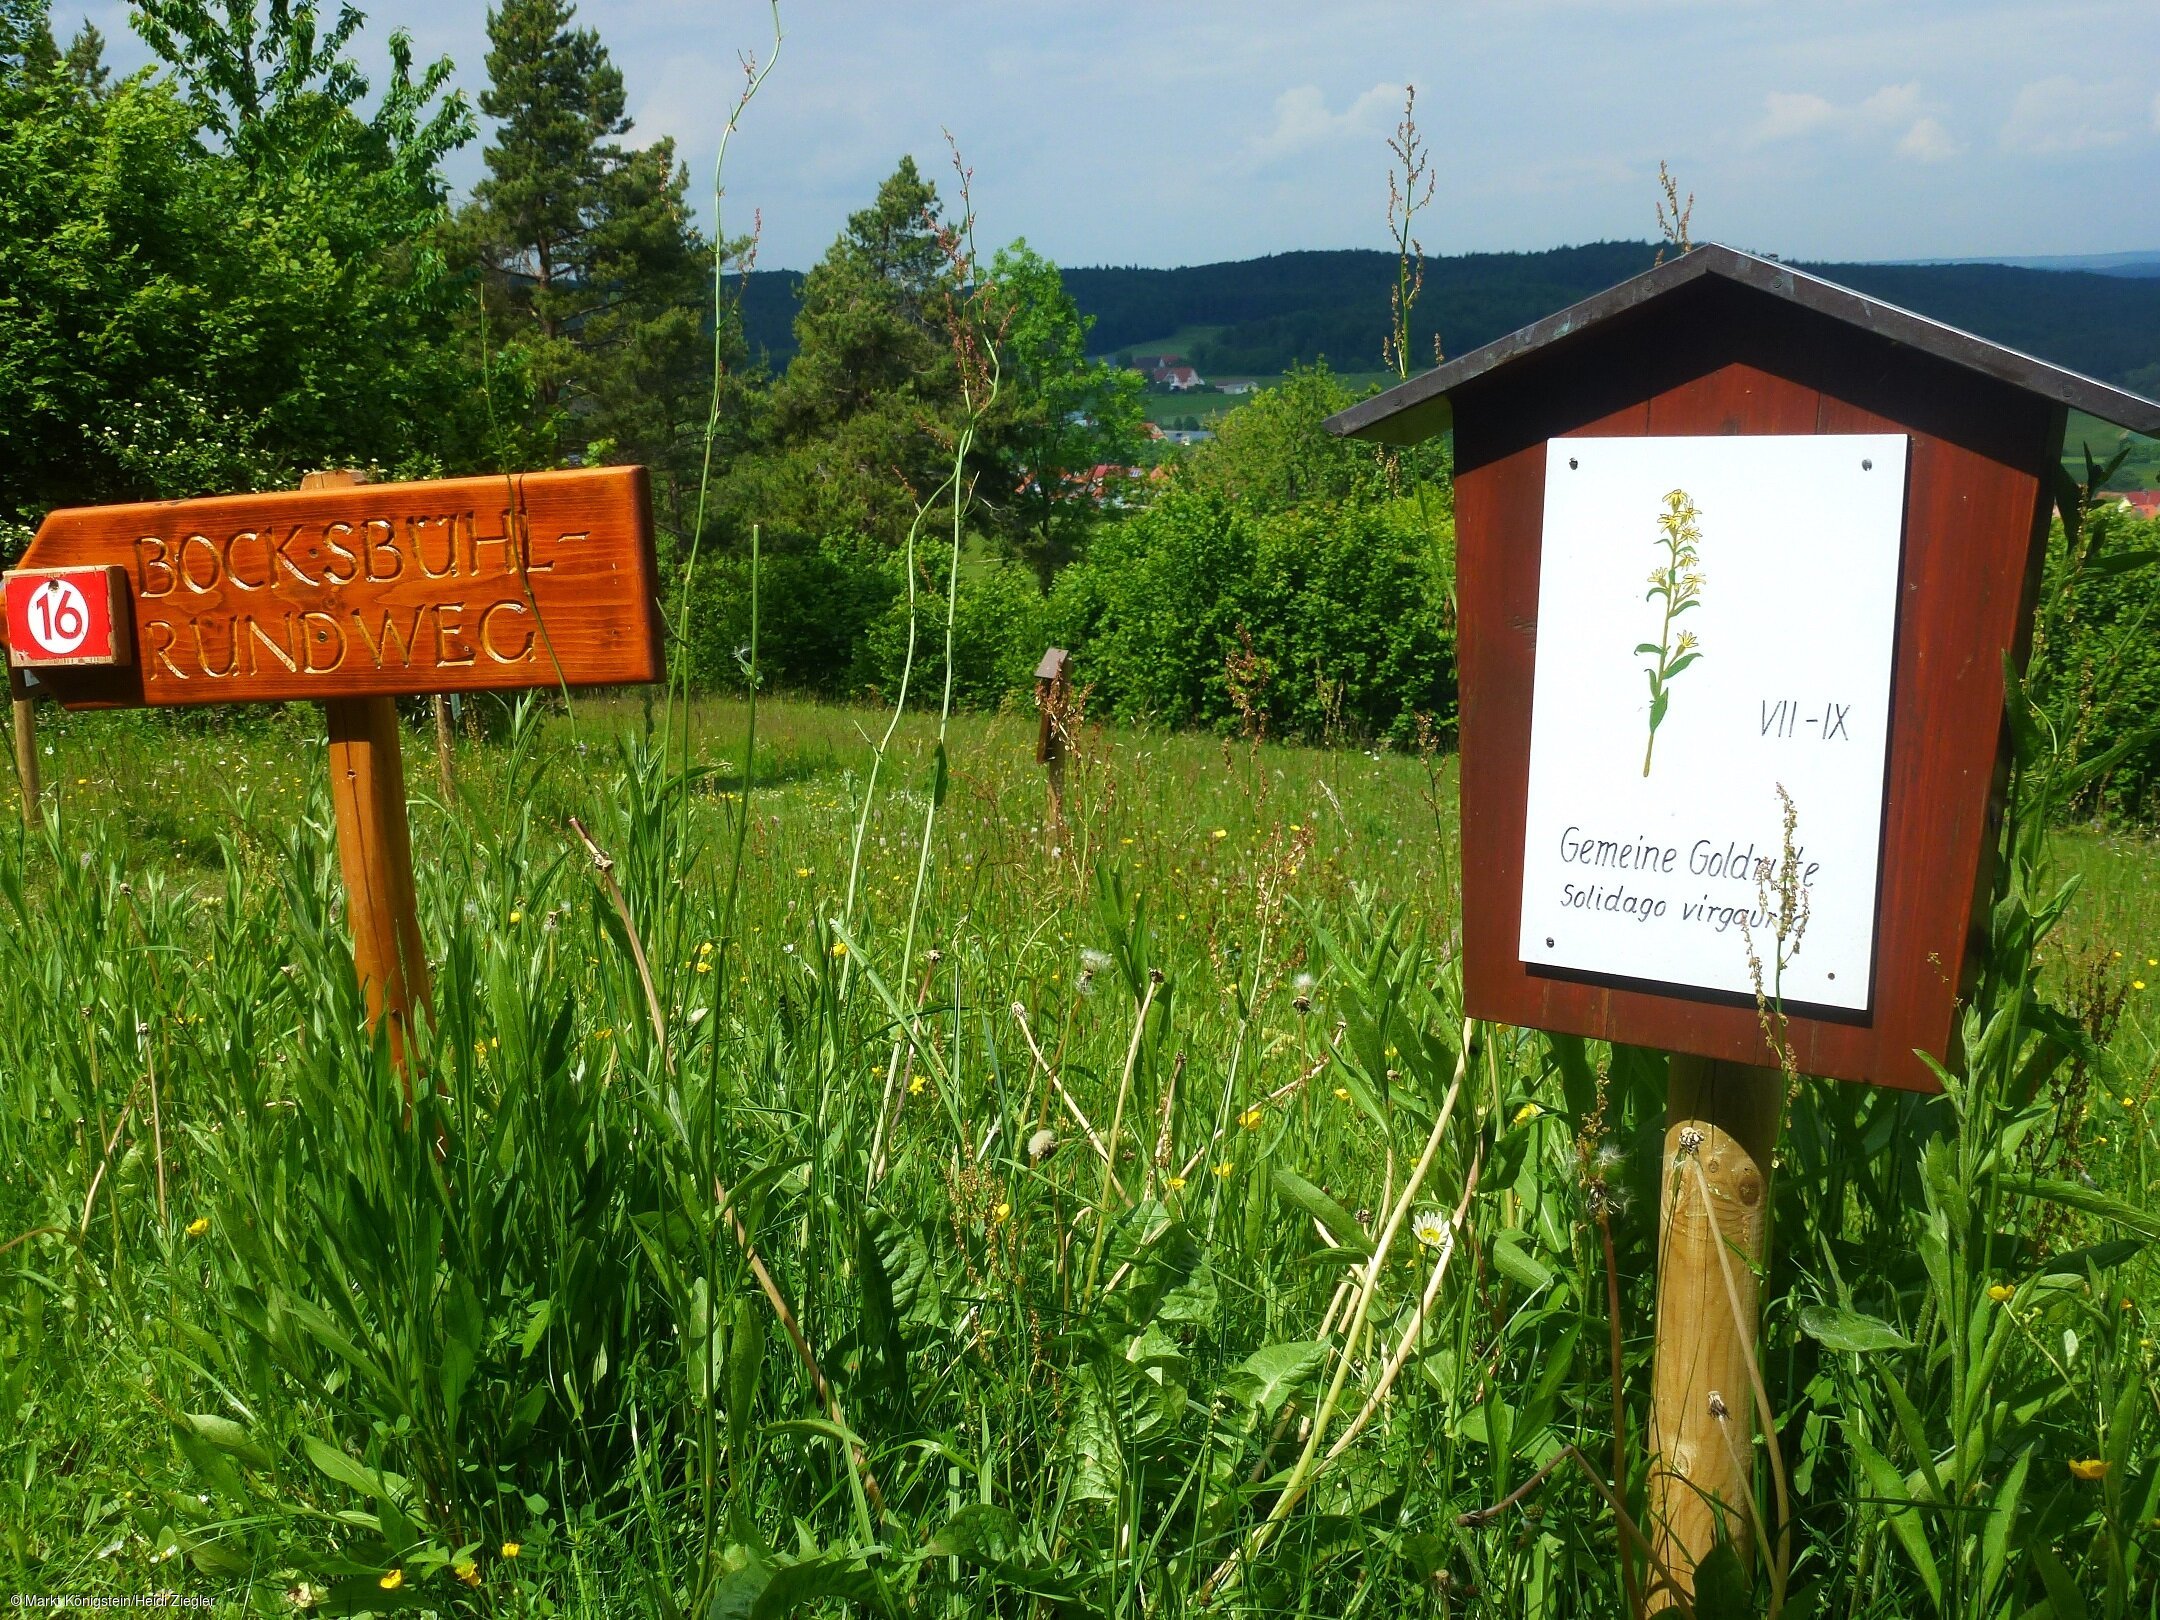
[6, 467, 661, 708]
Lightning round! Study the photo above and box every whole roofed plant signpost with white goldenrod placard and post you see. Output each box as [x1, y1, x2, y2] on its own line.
[1331, 246, 2160, 1607]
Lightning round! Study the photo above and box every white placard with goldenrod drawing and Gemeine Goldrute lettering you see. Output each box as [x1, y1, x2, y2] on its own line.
[1521, 434, 1905, 1011]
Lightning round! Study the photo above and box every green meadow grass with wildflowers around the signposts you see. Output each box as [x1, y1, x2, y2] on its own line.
[0, 700, 2160, 1618]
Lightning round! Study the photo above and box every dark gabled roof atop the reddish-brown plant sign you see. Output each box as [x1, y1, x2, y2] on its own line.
[1328, 242, 2160, 445]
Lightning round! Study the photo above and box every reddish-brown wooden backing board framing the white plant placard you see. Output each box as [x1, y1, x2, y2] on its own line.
[1452, 283, 2063, 1091]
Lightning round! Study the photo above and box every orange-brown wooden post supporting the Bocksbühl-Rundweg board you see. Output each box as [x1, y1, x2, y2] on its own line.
[300, 471, 434, 1074]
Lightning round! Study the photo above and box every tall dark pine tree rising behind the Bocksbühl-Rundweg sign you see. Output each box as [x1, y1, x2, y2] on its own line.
[462, 0, 711, 529]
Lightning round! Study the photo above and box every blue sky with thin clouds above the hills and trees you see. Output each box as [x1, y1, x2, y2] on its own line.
[54, 0, 2160, 268]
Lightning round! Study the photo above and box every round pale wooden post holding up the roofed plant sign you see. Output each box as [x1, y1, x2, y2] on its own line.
[1650, 1052, 1784, 1609]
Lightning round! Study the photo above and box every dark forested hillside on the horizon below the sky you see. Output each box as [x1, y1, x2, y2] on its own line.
[743, 242, 2160, 391]
